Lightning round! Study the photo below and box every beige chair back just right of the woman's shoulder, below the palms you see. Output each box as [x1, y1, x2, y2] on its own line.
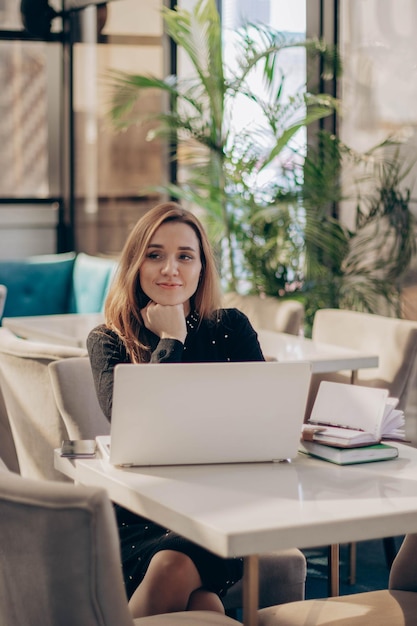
[222, 292, 304, 335]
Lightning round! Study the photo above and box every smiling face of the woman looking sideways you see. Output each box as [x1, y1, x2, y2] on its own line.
[139, 222, 202, 306]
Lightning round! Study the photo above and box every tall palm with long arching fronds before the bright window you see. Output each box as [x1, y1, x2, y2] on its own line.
[111, 0, 339, 295]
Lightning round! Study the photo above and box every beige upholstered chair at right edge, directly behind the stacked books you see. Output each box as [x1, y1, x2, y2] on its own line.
[312, 309, 417, 409]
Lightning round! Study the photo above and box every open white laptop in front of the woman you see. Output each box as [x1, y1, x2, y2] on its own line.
[97, 362, 310, 466]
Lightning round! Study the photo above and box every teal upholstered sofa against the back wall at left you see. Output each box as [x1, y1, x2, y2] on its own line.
[0, 252, 117, 317]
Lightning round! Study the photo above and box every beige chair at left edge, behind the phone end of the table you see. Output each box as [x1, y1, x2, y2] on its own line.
[0, 328, 87, 481]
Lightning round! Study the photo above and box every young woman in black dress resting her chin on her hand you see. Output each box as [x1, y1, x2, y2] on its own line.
[87, 202, 264, 617]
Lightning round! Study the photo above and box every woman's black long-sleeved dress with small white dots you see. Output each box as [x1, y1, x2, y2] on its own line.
[87, 309, 264, 598]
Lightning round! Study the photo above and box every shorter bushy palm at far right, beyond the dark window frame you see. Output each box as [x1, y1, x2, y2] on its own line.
[302, 135, 416, 332]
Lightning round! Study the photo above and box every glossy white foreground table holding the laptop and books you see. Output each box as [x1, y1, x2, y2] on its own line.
[55, 444, 417, 626]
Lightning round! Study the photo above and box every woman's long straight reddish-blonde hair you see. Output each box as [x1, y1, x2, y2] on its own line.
[104, 202, 221, 363]
